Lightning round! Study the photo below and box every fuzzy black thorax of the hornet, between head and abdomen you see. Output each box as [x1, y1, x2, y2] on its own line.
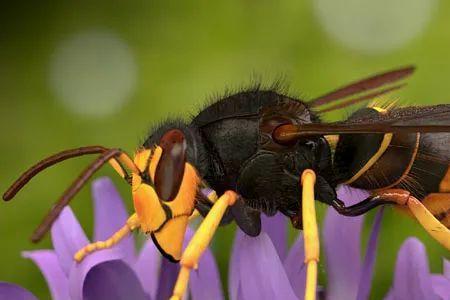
[144, 90, 336, 236]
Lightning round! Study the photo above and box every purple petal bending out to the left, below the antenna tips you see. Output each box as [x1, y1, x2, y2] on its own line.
[21, 250, 69, 300]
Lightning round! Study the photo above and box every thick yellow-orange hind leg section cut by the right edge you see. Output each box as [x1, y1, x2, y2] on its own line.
[407, 196, 450, 250]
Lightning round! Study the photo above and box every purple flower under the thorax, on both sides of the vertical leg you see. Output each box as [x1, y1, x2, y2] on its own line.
[229, 188, 382, 300]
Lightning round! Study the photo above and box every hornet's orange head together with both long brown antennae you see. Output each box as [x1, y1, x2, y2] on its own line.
[3, 122, 206, 261]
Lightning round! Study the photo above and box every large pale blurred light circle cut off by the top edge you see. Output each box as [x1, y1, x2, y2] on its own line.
[313, 0, 437, 54]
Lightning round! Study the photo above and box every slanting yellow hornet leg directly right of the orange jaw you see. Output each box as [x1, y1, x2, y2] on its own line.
[171, 191, 237, 300]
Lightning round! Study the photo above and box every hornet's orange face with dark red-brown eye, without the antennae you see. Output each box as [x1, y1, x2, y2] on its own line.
[132, 120, 207, 261]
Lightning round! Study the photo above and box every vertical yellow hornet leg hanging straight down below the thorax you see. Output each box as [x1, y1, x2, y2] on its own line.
[302, 170, 320, 300]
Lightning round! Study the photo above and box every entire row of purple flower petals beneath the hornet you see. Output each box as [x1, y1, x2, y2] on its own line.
[0, 179, 450, 300]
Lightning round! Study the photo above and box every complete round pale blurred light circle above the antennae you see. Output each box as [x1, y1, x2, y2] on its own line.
[50, 30, 137, 117]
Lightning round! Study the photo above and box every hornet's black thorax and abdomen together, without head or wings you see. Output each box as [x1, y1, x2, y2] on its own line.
[143, 90, 450, 236]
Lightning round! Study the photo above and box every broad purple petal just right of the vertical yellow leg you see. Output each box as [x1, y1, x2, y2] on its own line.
[323, 196, 363, 299]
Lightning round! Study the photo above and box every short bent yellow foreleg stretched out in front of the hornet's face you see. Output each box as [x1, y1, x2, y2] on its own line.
[74, 214, 139, 262]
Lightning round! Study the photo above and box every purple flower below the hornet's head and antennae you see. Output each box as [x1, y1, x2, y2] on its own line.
[23, 178, 223, 300]
